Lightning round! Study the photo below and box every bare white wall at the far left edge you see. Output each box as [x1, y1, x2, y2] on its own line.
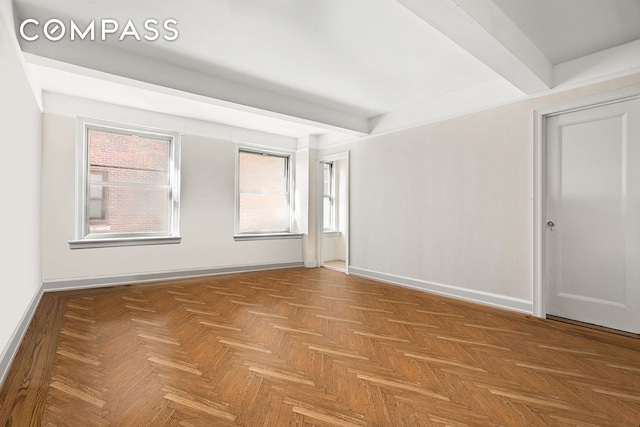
[0, 2, 42, 382]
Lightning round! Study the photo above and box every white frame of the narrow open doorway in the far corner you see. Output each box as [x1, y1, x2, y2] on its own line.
[315, 151, 351, 274]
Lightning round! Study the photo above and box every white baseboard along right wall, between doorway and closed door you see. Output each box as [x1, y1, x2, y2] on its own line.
[349, 266, 533, 314]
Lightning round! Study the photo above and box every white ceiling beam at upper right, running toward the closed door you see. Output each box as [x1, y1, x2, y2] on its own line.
[397, 0, 553, 94]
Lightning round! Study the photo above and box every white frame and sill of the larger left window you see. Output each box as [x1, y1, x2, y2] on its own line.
[69, 117, 181, 249]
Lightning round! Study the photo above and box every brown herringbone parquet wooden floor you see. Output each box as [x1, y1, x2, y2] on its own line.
[0, 269, 640, 427]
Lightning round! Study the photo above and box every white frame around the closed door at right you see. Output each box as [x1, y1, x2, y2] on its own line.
[532, 85, 640, 318]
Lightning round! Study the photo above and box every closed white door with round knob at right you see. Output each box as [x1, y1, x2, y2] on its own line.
[545, 99, 640, 333]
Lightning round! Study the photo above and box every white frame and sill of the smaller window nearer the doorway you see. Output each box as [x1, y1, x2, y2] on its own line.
[233, 145, 302, 241]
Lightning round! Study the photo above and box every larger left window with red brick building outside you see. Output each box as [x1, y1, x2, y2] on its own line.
[70, 119, 180, 249]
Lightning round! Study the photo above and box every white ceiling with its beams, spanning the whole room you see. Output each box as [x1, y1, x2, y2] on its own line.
[13, 0, 640, 145]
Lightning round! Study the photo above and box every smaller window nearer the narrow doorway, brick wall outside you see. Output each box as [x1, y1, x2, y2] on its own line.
[236, 149, 291, 238]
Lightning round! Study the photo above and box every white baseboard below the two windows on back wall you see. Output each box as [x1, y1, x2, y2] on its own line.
[44, 262, 304, 292]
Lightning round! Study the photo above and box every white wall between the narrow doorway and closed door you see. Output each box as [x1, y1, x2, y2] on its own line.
[319, 74, 640, 311]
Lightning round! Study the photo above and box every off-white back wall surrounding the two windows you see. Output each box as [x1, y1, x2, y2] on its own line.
[42, 112, 302, 284]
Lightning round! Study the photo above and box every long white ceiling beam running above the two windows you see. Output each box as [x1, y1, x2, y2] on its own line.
[22, 38, 370, 136]
